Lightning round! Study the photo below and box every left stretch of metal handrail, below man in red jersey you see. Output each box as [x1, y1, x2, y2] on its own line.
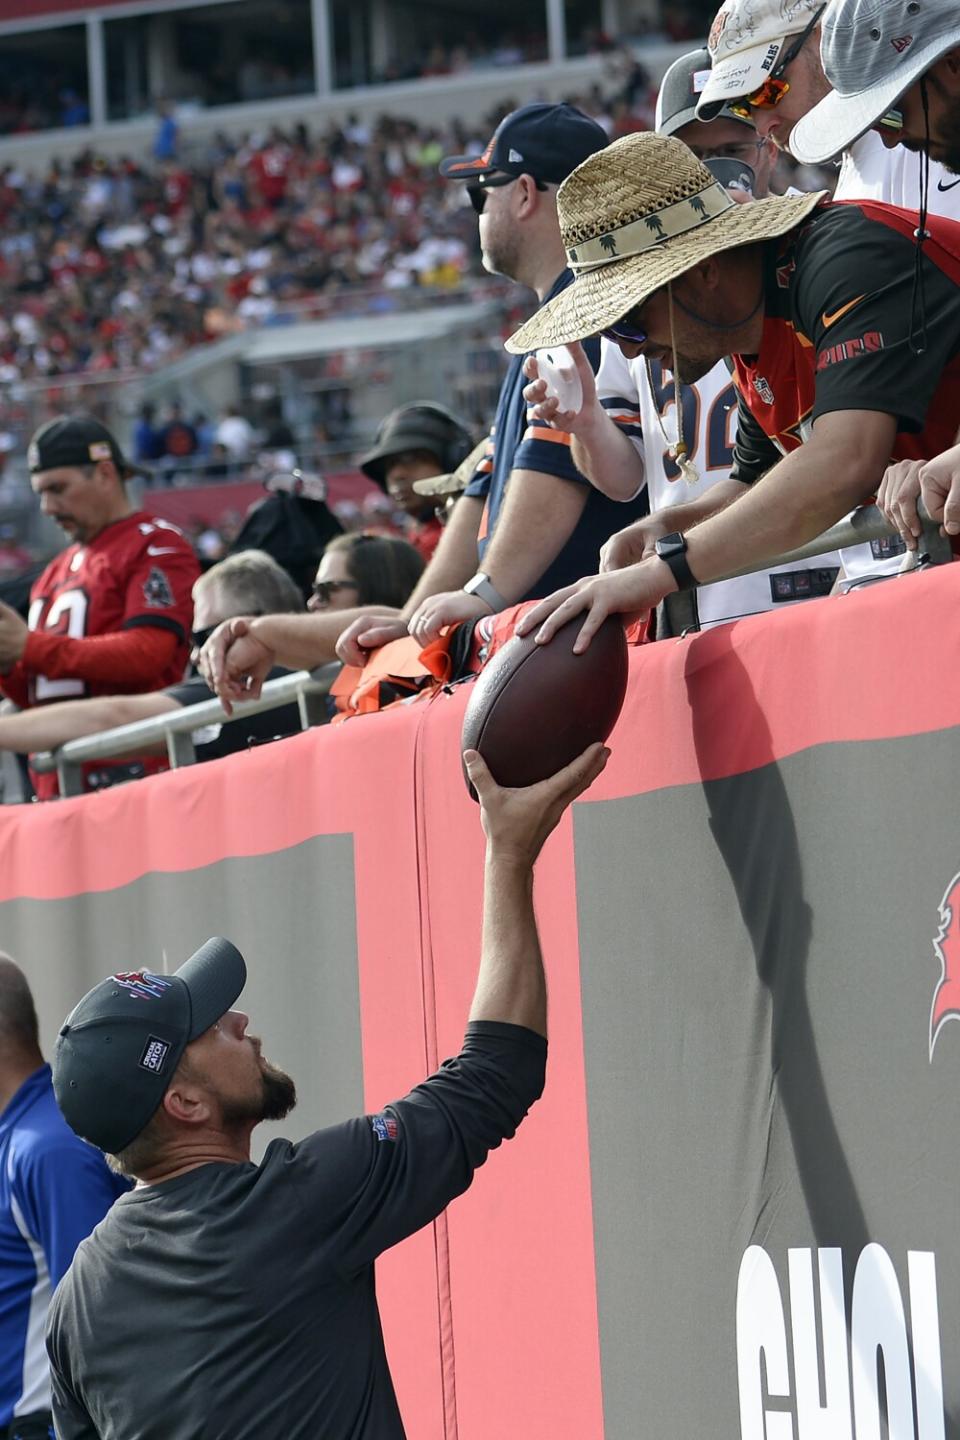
[30, 664, 340, 795]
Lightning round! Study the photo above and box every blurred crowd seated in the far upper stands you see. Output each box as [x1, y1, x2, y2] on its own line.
[0, 56, 829, 387]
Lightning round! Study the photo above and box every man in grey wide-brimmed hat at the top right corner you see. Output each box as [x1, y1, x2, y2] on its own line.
[793, 0, 960, 549]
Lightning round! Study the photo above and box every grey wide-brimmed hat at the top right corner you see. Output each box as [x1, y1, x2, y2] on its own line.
[790, 0, 960, 164]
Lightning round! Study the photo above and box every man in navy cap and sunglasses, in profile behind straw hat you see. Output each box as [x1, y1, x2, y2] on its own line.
[337, 104, 646, 665]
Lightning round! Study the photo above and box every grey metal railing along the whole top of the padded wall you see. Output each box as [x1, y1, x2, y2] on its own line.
[32, 505, 953, 795]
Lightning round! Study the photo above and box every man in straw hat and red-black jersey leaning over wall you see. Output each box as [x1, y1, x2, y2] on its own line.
[507, 134, 960, 651]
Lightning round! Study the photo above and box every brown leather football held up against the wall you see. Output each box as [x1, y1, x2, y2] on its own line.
[461, 615, 628, 799]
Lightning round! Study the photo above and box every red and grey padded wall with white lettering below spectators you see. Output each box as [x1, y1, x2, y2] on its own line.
[0, 566, 960, 1440]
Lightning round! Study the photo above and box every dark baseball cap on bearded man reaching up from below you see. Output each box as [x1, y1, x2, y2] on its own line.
[52, 936, 246, 1155]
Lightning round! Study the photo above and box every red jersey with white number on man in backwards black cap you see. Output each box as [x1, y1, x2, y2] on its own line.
[27, 510, 200, 704]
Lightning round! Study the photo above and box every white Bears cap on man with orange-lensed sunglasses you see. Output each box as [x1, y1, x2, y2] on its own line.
[697, 0, 826, 120]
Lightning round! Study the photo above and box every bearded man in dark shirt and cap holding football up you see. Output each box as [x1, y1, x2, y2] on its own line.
[47, 744, 607, 1440]
